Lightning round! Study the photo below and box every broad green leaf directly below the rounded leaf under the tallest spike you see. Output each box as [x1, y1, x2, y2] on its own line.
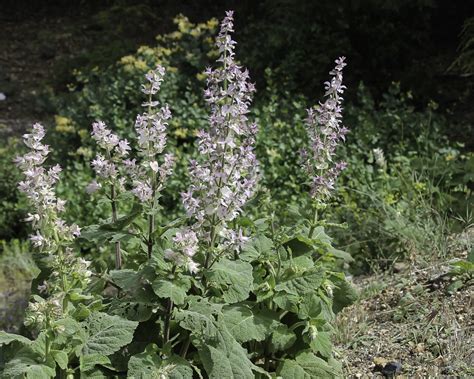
[222, 305, 280, 343]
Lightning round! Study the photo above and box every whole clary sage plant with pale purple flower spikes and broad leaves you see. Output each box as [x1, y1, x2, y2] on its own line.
[0, 11, 352, 379]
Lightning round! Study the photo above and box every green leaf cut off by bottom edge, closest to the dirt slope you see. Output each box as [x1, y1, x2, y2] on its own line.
[277, 352, 340, 379]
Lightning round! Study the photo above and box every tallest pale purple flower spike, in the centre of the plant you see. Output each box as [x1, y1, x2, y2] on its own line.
[182, 11, 258, 255]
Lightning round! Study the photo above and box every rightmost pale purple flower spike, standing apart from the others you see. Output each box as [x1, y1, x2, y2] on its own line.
[302, 57, 348, 198]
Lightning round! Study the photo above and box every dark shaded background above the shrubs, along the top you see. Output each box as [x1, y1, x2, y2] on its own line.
[0, 0, 474, 140]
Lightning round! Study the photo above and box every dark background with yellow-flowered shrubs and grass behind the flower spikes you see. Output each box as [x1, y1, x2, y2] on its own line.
[0, 0, 474, 378]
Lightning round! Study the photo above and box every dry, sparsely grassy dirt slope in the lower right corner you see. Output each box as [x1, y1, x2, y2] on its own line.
[336, 230, 474, 378]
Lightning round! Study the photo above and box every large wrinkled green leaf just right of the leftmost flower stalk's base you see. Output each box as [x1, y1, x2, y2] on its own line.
[83, 312, 138, 355]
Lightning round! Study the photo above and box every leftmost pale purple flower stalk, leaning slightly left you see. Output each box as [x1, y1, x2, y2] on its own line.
[16, 124, 91, 326]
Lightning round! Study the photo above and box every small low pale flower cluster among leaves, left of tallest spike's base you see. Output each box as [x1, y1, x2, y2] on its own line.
[165, 228, 199, 274]
